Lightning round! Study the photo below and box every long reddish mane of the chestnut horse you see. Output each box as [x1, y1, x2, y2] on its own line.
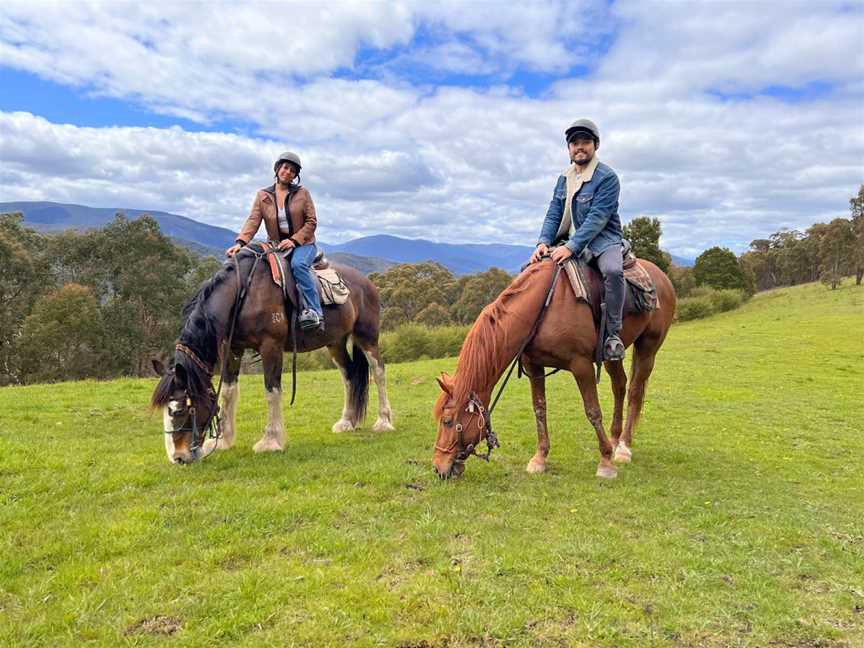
[435, 263, 551, 418]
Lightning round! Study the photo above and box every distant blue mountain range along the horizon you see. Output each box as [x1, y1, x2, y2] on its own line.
[0, 201, 693, 275]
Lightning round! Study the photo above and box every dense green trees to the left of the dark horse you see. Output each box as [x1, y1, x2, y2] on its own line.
[0, 214, 220, 385]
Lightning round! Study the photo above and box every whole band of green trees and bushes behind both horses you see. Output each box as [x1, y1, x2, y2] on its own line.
[0, 185, 864, 385]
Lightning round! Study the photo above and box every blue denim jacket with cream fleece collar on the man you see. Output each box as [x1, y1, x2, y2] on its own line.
[538, 162, 624, 258]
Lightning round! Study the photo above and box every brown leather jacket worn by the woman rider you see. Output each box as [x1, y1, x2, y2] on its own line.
[237, 185, 318, 245]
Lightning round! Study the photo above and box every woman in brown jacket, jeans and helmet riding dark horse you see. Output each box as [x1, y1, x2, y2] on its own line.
[225, 151, 324, 330]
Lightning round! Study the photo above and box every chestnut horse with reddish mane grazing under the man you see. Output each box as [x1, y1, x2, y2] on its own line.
[432, 260, 676, 479]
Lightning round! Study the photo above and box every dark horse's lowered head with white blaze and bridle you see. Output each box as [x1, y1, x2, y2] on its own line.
[150, 360, 218, 464]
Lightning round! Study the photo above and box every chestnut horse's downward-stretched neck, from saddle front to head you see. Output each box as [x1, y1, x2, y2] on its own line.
[453, 264, 552, 406]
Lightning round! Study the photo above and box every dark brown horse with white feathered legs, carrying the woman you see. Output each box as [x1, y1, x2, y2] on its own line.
[151, 248, 393, 463]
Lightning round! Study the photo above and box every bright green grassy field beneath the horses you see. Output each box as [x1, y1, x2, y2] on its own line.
[0, 285, 864, 648]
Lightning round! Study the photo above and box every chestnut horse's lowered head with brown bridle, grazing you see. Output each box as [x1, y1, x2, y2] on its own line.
[432, 373, 498, 479]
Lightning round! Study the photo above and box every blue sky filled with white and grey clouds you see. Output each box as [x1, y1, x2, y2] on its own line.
[0, 0, 864, 258]
